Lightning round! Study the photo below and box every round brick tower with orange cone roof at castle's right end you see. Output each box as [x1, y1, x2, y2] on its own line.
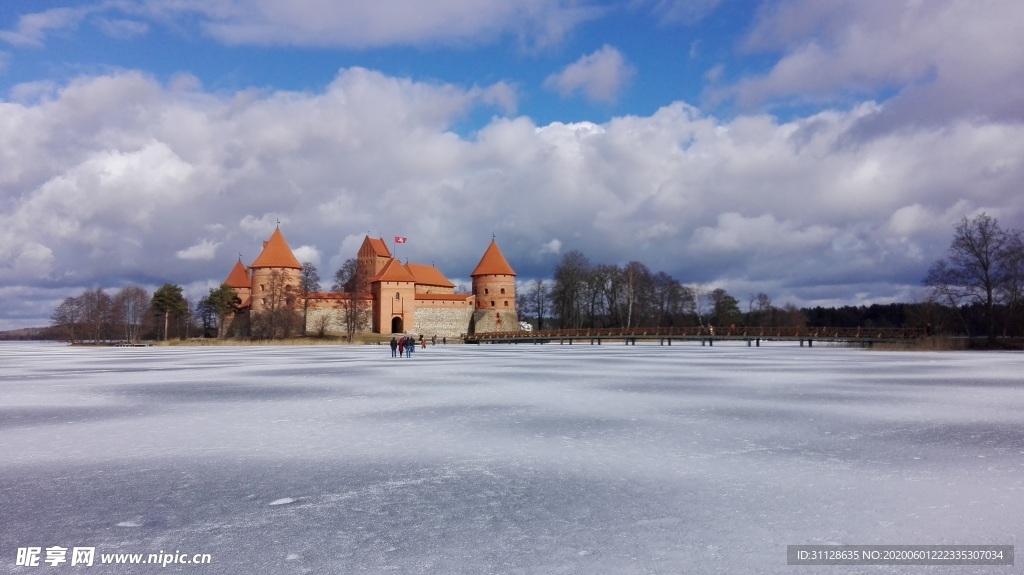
[470, 239, 519, 334]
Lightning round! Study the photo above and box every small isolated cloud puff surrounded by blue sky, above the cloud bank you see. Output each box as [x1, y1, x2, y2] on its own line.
[544, 45, 636, 102]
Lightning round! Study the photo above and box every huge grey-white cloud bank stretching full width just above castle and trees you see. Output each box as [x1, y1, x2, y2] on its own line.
[0, 63, 1024, 325]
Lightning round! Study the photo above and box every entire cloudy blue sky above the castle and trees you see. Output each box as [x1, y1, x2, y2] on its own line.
[0, 0, 1024, 329]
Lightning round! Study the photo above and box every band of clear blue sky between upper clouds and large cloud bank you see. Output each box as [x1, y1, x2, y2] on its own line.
[3, 2, 753, 125]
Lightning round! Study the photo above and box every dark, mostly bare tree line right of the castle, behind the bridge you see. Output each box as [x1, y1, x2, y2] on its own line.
[516, 213, 1024, 339]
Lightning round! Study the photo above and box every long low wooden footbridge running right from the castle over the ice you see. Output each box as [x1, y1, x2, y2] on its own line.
[464, 327, 927, 346]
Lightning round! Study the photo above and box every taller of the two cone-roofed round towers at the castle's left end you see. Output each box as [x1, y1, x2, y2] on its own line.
[249, 228, 302, 312]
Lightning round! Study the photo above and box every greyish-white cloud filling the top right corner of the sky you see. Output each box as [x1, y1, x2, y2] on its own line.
[713, 0, 1024, 123]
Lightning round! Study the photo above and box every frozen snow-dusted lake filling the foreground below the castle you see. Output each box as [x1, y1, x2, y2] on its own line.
[0, 343, 1024, 574]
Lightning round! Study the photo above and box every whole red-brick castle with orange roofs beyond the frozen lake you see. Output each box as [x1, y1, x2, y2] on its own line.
[224, 228, 519, 338]
